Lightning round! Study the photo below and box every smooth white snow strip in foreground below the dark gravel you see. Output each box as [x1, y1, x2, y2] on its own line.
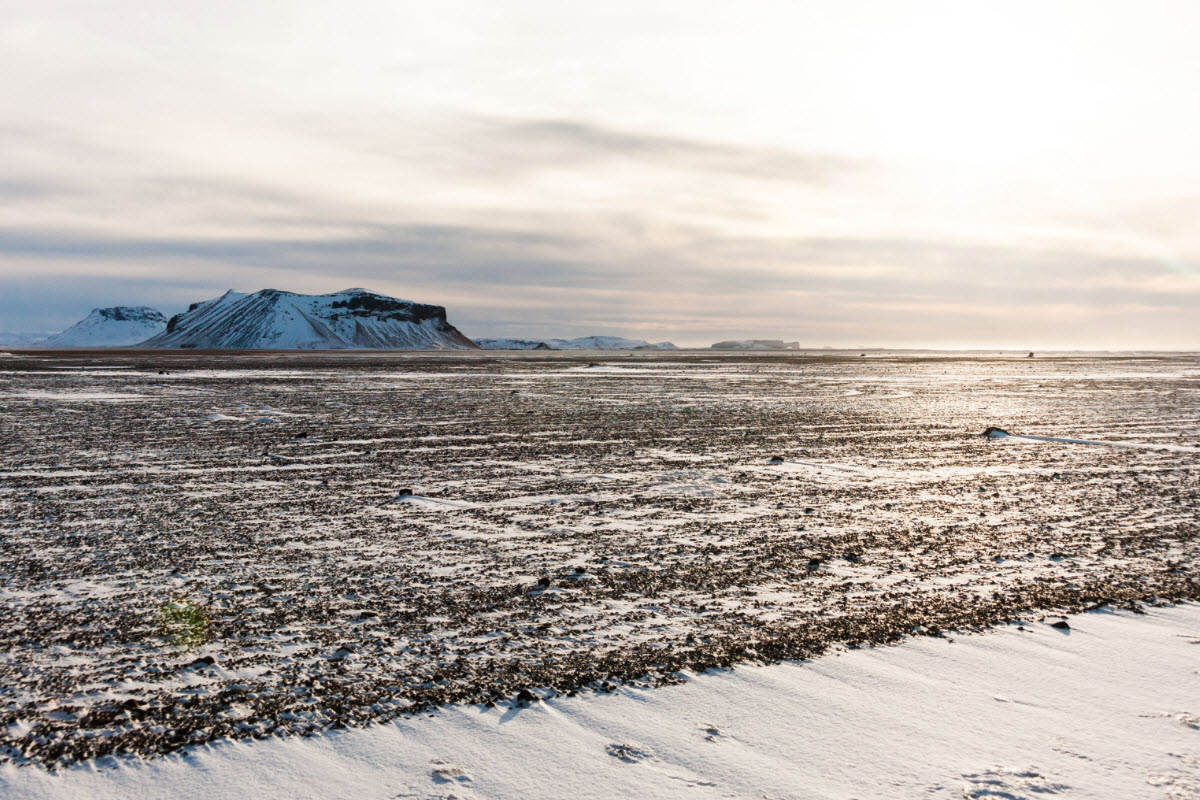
[0, 604, 1200, 800]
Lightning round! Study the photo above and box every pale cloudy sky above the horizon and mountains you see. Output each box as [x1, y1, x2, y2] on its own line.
[0, 0, 1200, 349]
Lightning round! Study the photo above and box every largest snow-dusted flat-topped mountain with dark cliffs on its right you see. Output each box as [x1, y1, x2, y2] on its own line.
[142, 289, 476, 350]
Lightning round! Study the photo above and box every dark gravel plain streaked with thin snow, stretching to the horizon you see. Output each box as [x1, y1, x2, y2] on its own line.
[0, 351, 1200, 768]
